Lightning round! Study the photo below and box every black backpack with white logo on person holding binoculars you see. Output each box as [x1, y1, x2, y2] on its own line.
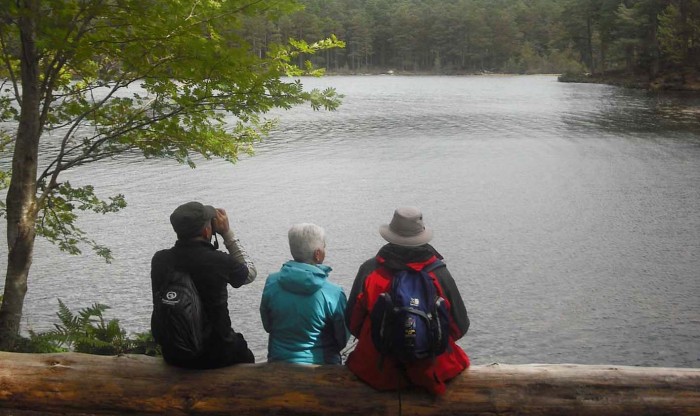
[151, 269, 205, 359]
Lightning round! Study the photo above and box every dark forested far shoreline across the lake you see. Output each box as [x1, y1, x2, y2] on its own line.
[244, 0, 700, 89]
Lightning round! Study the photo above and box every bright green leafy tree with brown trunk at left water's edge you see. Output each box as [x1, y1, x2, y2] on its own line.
[0, 0, 343, 349]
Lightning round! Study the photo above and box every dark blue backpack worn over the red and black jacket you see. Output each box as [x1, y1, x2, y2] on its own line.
[370, 260, 449, 363]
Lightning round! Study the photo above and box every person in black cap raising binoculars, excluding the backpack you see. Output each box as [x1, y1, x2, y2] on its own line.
[151, 202, 257, 369]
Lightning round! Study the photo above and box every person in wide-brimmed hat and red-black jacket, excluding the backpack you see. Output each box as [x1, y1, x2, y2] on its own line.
[346, 207, 469, 395]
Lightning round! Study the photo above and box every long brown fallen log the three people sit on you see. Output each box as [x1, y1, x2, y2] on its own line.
[0, 352, 700, 416]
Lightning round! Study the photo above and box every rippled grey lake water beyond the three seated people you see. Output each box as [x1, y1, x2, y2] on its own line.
[0, 76, 700, 367]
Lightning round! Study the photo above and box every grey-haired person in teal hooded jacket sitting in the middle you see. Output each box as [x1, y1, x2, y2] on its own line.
[260, 223, 350, 364]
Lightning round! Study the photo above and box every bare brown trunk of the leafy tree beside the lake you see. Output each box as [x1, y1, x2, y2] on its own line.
[0, 0, 41, 350]
